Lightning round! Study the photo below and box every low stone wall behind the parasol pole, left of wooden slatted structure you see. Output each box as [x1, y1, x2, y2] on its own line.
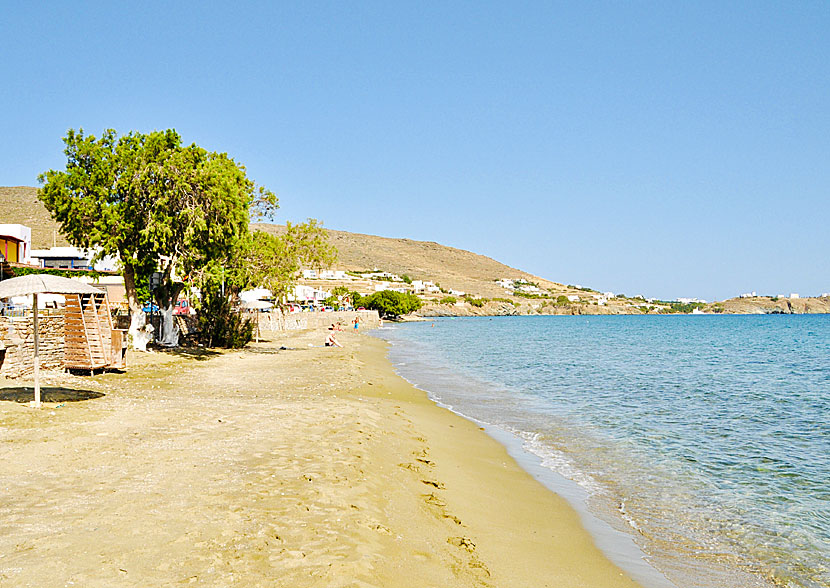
[0, 312, 64, 378]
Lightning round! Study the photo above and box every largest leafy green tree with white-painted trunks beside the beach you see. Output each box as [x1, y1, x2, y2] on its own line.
[38, 129, 278, 345]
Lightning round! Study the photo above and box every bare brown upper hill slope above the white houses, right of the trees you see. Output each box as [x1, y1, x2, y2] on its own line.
[253, 224, 571, 297]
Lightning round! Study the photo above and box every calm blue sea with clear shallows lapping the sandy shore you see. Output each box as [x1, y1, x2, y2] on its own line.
[374, 315, 830, 588]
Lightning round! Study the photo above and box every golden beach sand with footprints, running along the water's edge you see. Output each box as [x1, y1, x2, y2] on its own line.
[0, 332, 637, 588]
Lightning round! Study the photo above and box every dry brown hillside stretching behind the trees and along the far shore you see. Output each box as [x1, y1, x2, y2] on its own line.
[0, 187, 830, 316]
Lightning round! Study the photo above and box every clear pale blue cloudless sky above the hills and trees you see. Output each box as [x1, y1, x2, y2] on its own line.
[0, 0, 830, 300]
